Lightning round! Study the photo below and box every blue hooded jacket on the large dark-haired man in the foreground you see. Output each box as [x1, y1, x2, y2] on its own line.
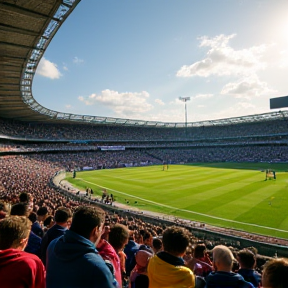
[46, 230, 115, 288]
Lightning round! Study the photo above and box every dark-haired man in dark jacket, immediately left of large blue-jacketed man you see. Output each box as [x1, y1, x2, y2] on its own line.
[40, 207, 72, 266]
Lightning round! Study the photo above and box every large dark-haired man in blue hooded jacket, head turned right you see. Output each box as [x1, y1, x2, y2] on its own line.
[47, 206, 114, 288]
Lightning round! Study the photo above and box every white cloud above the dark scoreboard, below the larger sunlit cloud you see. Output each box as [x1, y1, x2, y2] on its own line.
[221, 74, 277, 99]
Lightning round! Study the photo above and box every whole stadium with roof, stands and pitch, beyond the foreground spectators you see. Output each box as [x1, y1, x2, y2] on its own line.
[0, 0, 288, 287]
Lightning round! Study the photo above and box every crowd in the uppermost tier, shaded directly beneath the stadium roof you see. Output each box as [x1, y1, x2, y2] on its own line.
[0, 118, 288, 141]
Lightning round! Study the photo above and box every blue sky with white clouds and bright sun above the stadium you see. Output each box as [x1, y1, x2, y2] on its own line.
[32, 0, 288, 122]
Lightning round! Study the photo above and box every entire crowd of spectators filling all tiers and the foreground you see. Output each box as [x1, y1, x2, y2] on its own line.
[0, 116, 288, 288]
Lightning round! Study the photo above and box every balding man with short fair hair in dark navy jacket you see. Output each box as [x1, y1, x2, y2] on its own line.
[206, 245, 254, 288]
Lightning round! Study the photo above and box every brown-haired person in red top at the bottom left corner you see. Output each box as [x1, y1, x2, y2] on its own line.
[0, 216, 45, 288]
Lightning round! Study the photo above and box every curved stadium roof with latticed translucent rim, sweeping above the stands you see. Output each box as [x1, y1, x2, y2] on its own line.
[0, 0, 288, 127]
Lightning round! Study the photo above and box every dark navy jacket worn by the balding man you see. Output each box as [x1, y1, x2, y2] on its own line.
[205, 271, 254, 288]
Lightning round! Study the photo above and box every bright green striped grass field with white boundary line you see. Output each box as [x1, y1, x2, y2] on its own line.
[67, 163, 288, 238]
